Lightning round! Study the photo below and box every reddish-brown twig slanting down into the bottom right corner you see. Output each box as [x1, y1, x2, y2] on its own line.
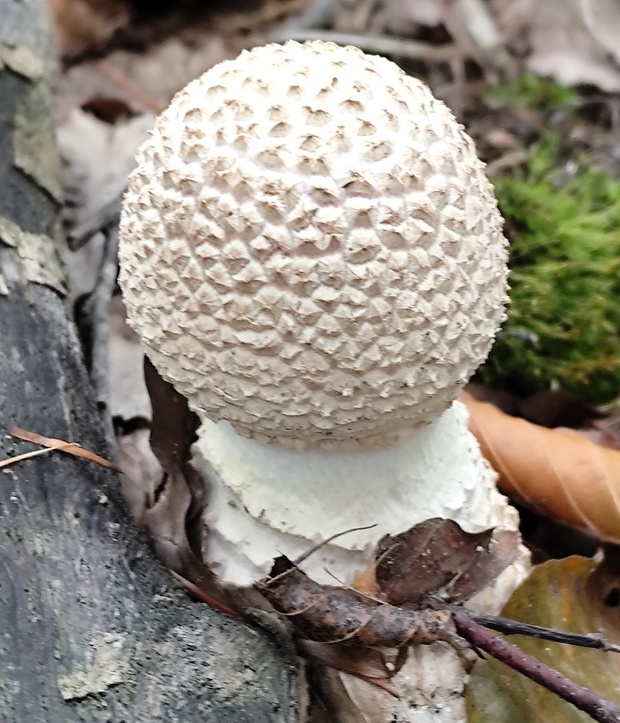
[430, 600, 620, 723]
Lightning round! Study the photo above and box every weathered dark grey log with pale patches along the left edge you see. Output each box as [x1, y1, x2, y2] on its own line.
[0, 0, 303, 723]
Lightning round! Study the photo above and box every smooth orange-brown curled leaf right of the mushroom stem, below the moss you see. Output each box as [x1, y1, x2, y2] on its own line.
[463, 398, 620, 543]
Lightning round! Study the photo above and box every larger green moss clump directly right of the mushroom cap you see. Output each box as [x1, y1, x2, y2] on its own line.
[480, 135, 620, 403]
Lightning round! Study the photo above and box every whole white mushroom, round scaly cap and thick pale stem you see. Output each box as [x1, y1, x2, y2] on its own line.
[120, 42, 518, 720]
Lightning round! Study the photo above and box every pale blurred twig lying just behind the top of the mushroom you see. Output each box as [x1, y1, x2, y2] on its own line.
[276, 28, 466, 63]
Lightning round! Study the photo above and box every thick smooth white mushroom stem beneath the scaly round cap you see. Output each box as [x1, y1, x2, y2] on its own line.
[194, 402, 518, 585]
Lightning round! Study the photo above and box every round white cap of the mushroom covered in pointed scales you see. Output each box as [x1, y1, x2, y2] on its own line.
[120, 42, 507, 448]
